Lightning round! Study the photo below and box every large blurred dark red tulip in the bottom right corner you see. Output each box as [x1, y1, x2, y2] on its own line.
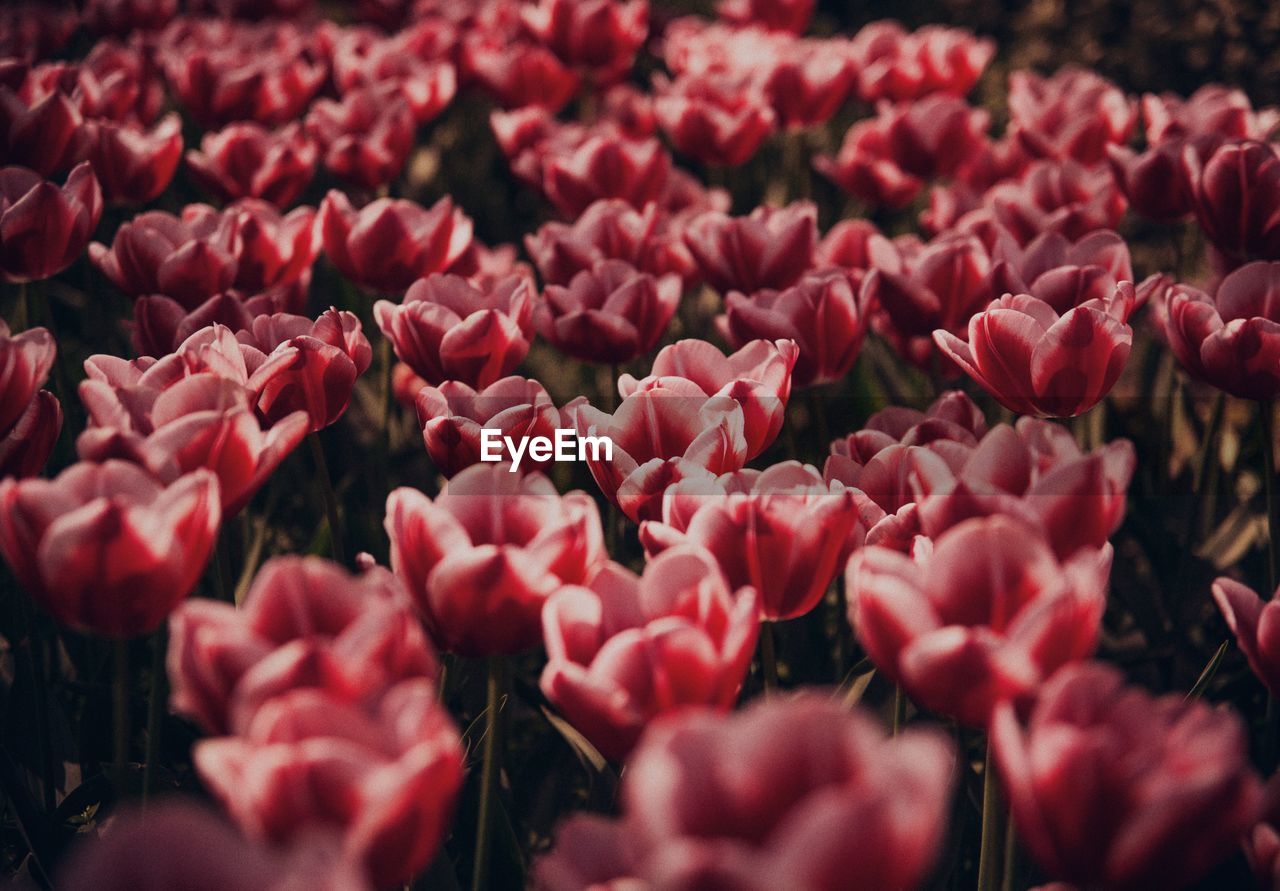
[991, 664, 1262, 888]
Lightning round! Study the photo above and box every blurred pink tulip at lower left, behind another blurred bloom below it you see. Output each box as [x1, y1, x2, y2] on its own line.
[166, 557, 439, 736]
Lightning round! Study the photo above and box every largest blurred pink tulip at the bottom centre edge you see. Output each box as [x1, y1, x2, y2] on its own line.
[535, 695, 955, 891]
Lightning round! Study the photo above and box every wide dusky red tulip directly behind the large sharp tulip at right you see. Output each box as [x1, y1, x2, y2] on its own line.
[913, 417, 1137, 559]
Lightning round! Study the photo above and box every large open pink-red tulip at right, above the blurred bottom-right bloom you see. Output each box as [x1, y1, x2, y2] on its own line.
[846, 516, 1111, 727]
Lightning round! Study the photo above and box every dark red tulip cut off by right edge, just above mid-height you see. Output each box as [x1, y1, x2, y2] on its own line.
[1165, 261, 1280, 399]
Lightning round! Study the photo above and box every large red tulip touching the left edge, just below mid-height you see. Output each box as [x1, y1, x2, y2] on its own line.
[0, 461, 220, 638]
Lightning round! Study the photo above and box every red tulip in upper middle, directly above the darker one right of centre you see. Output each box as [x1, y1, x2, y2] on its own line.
[685, 201, 818, 294]
